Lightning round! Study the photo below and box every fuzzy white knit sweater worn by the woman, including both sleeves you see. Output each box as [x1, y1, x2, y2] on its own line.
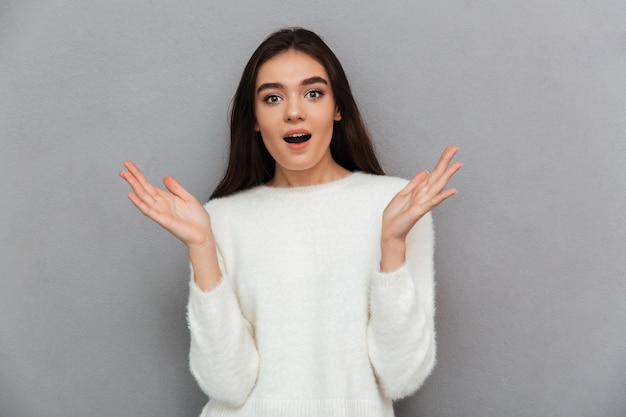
[187, 172, 435, 417]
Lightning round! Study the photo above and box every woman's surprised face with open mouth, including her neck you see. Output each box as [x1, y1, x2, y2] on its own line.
[254, 50, 341, 182]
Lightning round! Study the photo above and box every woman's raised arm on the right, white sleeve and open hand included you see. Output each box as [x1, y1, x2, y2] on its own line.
[368, 147, 461, 399]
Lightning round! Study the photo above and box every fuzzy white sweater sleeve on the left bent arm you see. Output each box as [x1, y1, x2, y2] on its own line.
[187, 262, 259, 407]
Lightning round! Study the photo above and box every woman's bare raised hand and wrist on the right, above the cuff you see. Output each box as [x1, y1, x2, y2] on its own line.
[381, 146, 462, 271]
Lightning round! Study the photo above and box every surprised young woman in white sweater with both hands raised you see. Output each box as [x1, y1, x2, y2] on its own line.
[120, 29, 461, 417]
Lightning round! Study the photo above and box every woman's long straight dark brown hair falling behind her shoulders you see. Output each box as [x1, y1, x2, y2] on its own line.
[211, 28, 384, 199]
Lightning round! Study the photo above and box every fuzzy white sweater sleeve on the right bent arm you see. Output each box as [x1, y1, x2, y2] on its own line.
[367, 213, 436, 400]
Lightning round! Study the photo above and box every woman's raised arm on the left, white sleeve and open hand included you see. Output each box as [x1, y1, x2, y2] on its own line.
[120, 161, 258, 406]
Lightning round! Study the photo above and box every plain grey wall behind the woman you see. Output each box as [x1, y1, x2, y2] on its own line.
[0, 0, 626, 417]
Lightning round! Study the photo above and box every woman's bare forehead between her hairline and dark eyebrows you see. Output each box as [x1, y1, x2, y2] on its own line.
[256, 50, 330, 87]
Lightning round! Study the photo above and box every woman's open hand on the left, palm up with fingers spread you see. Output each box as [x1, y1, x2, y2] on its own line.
[120, 161, 213, 249]
